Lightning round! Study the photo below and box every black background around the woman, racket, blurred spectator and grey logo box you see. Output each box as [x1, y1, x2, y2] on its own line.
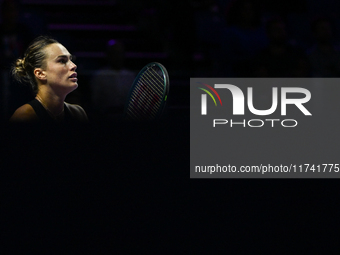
[0, 0, 339, 254]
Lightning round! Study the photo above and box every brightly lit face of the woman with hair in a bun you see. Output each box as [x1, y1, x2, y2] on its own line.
[44, 43, 78, 94]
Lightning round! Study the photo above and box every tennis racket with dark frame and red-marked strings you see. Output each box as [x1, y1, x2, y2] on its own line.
[124, 62, 170, 121]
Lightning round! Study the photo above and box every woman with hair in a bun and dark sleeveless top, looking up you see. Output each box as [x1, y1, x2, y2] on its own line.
[10, 36, 88, 123]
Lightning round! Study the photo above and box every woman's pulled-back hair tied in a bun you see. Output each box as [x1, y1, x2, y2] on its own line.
[12, 36, 59, 93]
